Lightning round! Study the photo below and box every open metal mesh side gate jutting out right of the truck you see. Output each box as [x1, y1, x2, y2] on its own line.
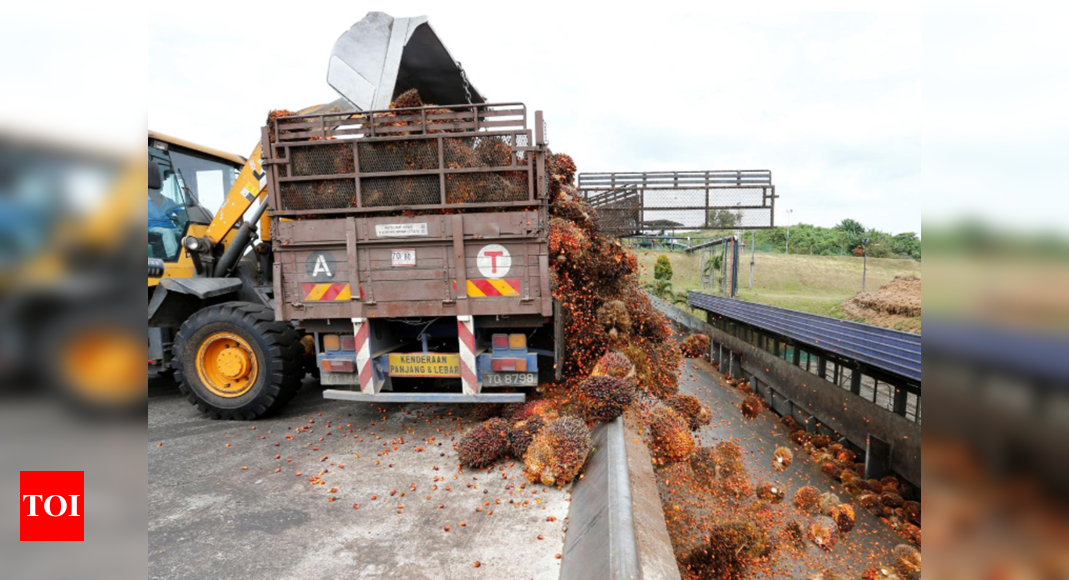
[579, 170, 776, 237]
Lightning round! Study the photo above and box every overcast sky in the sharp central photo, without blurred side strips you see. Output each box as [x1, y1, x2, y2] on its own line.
[140, 2, 921, 233]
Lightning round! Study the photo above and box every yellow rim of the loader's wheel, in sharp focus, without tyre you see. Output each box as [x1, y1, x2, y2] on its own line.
[197, 332, 259, 398]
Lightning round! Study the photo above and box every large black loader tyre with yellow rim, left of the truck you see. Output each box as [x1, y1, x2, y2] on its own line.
[172, 302, 304, 420]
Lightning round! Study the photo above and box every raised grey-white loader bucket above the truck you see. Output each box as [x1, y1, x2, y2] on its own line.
[327, 12, 485, 111]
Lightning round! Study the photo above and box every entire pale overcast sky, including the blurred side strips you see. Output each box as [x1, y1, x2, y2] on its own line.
[0, 0, 1069, 233]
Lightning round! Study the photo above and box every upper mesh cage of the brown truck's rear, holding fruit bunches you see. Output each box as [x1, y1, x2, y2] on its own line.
[263, 103, 545, 217]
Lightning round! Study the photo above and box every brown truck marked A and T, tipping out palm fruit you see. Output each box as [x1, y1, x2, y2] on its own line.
[261, 103, 562, 403]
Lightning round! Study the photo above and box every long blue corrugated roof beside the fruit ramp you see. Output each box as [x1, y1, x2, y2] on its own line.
[690, 292, 920, 382]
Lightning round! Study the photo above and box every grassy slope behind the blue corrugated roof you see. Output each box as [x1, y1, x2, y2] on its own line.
[635, 250, 920, 318]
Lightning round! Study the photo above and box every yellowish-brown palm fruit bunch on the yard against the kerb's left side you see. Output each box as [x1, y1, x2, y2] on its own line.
[524, 417, 590, 486]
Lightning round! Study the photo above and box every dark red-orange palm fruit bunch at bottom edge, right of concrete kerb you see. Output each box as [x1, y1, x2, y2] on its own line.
[680, 520, 773, 580]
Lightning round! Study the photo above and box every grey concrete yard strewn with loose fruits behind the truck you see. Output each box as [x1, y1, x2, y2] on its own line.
[148, 378, 570, 580]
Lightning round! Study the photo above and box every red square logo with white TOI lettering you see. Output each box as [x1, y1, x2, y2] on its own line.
[18, 471, 86, 542]
